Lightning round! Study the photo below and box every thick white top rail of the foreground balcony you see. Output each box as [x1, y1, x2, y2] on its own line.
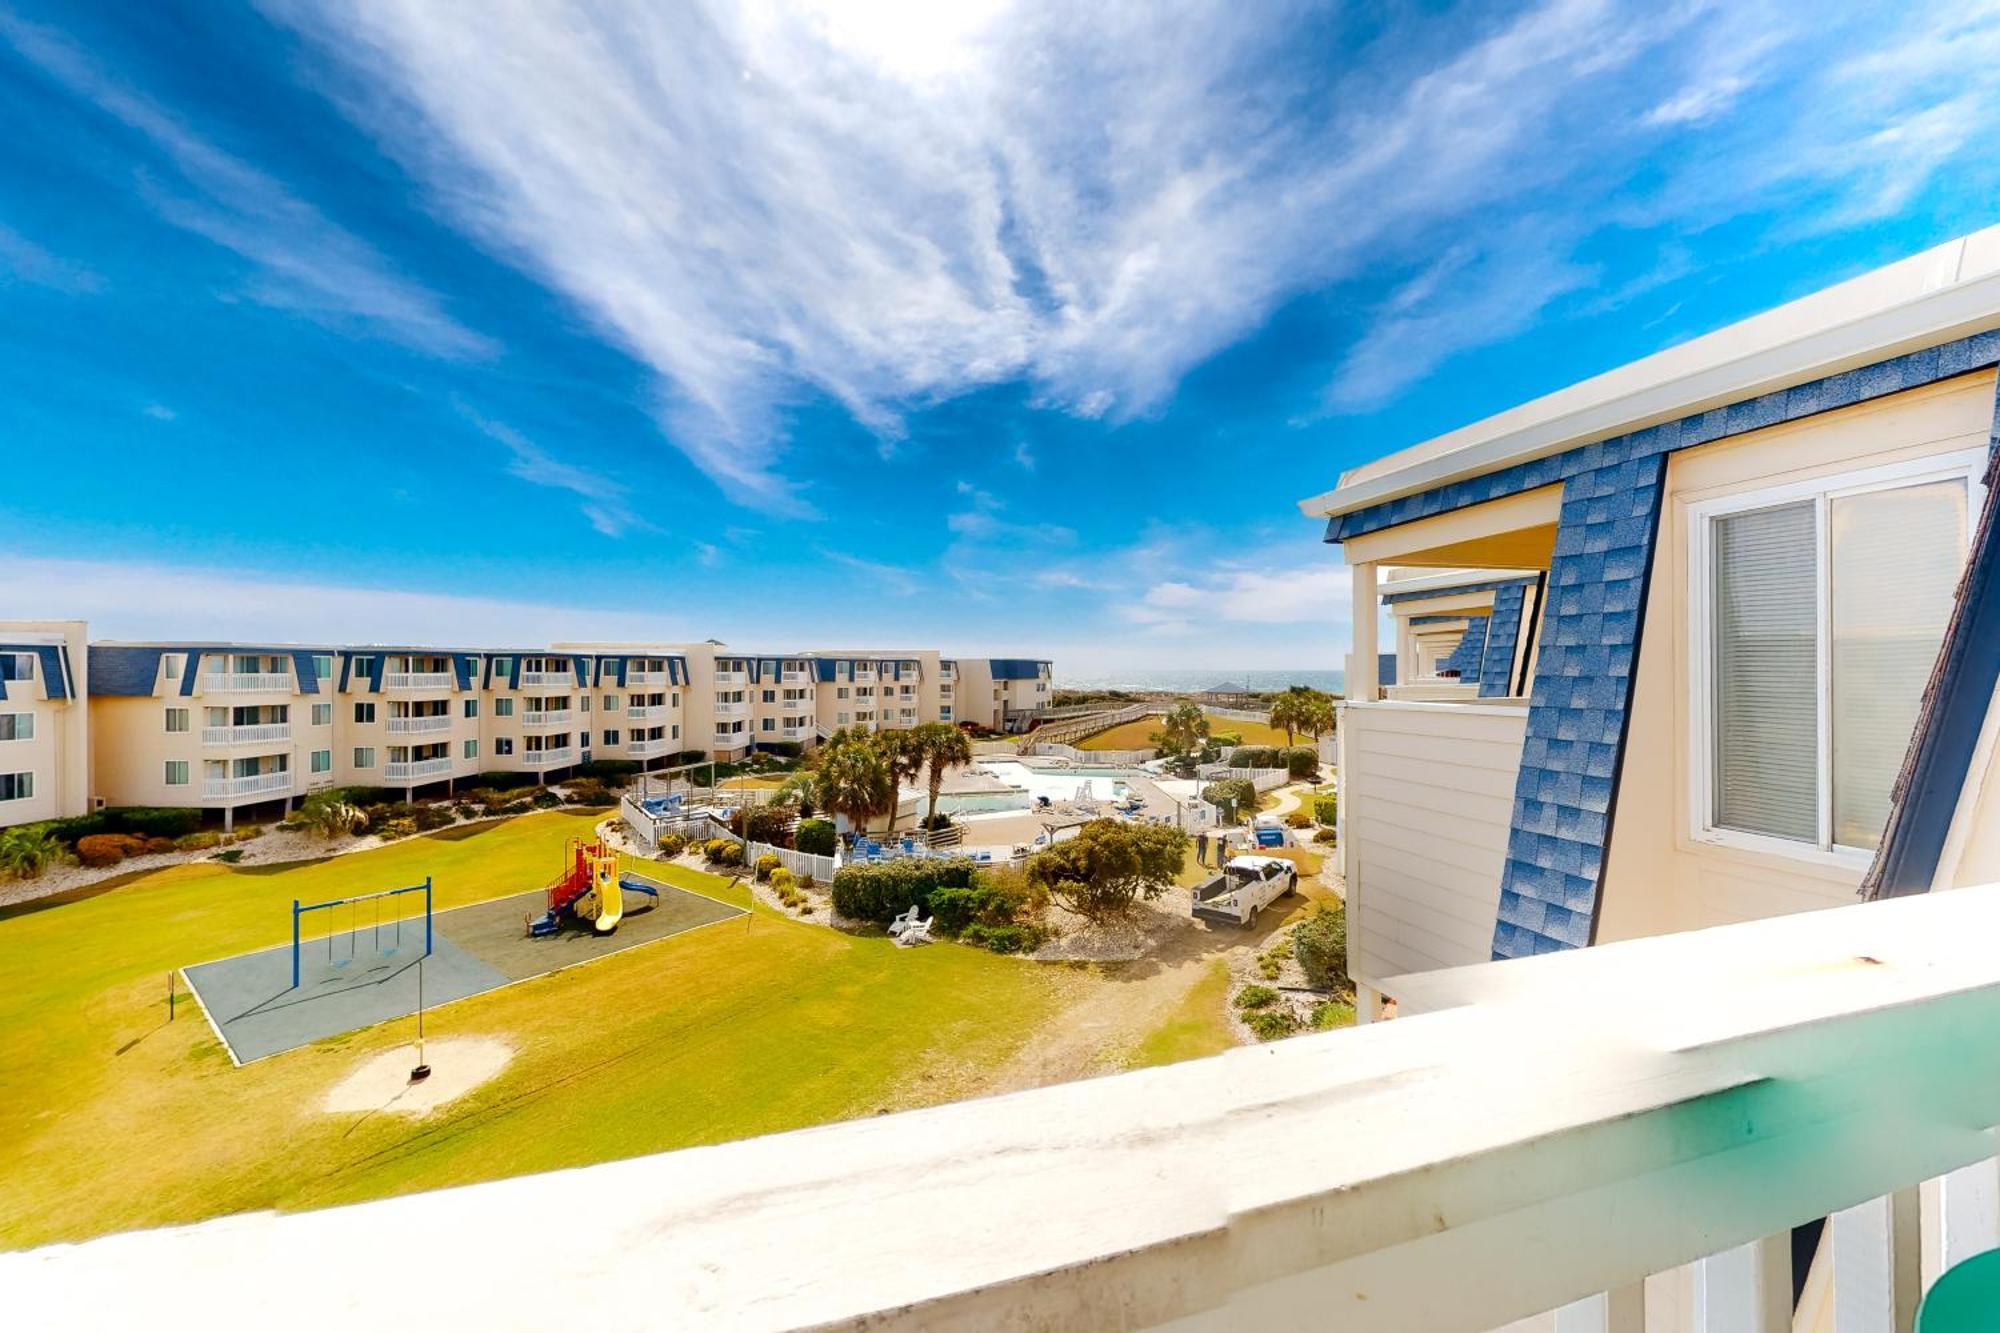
[23, 887, 2000, 1333]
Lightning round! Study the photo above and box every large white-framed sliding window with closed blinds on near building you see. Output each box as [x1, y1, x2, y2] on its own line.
[1690, 450, 1984, 867]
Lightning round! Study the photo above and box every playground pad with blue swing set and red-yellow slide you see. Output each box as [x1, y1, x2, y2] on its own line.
[182, 845, 744, 1065]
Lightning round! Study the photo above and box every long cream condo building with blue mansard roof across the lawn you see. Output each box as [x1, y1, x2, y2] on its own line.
[0, 636, 1050, 827]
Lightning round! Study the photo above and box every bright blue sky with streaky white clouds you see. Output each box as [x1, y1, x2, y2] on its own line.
[0, 0, 2000, 673]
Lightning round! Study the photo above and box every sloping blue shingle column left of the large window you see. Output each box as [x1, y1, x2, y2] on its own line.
[1494, 454, 1666, 959]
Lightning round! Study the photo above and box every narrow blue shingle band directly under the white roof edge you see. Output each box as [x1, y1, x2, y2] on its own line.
[1326, 330, 2000, 544]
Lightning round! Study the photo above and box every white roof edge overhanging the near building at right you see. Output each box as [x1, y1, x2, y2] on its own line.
[1298, 226, 2000, 518]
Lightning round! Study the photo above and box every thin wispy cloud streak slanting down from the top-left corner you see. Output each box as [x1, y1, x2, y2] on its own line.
[0, 12, 496, 356]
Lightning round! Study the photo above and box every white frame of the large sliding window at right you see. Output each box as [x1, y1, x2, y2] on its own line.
[1686, 448, 1988, 860]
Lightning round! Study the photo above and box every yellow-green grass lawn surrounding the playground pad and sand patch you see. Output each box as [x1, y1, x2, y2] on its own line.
[0, 811, 1064, 1247]
